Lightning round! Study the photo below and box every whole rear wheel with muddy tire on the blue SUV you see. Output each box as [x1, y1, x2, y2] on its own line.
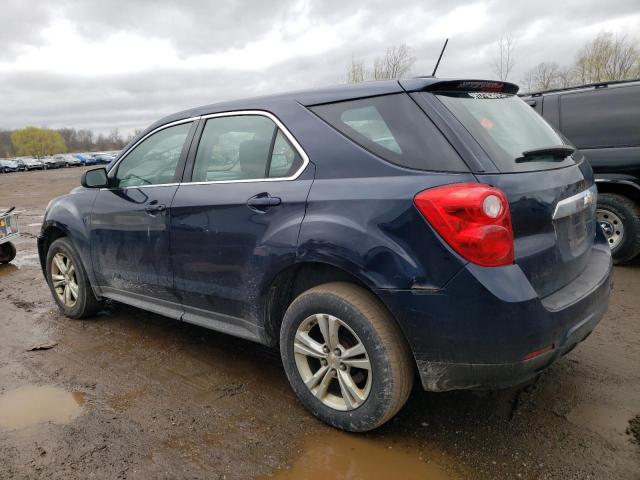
[280, 282, 414, 432]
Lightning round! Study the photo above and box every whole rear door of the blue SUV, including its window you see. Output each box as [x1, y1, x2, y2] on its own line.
[171, 112, 313, 339]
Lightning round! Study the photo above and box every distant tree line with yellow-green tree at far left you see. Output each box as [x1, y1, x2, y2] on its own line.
[0, 127, 136, 158]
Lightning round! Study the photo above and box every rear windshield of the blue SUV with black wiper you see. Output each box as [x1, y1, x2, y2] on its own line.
[436, 92, 575, 172]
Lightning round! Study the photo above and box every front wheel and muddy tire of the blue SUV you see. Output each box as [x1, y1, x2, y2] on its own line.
[46, 238, 103, 318]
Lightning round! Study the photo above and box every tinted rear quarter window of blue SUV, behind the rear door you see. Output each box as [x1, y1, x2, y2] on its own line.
[311, 94, 469, 172]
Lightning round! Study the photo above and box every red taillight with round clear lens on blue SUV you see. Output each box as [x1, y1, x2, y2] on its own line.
[414, 183, 514, 267]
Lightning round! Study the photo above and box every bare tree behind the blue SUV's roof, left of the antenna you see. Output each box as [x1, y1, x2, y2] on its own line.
[347, 44, 416, 83]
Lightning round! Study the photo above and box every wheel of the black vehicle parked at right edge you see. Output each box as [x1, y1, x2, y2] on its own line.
[597, 193, 640, 264]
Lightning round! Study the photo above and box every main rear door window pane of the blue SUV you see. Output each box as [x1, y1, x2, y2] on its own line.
[191, 115, 276, 182]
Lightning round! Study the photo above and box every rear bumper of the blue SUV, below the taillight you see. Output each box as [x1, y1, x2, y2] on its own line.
[378, 238, 612, 391]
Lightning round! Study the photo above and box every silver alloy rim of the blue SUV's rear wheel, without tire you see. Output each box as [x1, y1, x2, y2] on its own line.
[293, 314, 372, 411]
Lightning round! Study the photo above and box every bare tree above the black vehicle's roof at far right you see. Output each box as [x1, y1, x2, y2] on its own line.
[576, 32, 640, 83]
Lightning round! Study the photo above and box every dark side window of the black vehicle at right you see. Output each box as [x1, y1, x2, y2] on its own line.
[560, 86, 640, 148]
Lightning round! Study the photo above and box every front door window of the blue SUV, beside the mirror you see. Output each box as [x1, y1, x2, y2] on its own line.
[115, 123, 192, 188]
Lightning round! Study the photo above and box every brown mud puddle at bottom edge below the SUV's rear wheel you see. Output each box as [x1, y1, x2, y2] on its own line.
[261, 431, 461, 480]
